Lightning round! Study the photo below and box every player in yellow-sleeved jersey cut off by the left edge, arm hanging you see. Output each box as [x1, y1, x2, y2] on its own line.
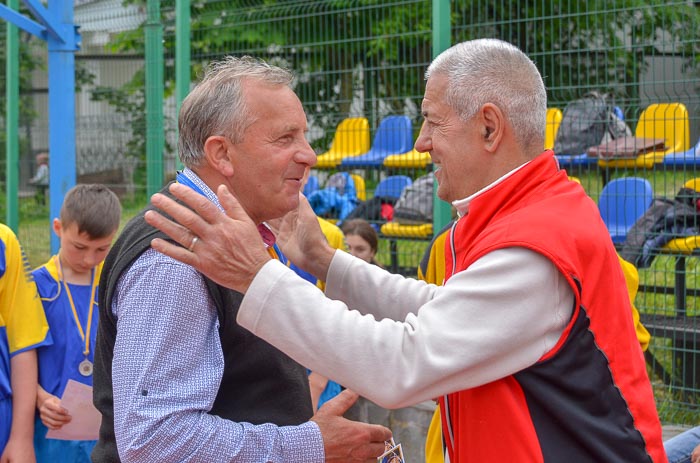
[0, 224, 51, 462]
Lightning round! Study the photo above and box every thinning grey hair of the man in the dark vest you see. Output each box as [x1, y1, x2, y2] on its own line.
[178, 56, 294, 167]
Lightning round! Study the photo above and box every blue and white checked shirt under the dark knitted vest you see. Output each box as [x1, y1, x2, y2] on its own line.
[112, 169, 324, 463]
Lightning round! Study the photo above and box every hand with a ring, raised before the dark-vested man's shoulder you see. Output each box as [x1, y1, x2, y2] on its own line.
[145, 183, 271, 293]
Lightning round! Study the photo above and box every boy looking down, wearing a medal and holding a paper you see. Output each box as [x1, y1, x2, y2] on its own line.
[33, 184, 121, 463]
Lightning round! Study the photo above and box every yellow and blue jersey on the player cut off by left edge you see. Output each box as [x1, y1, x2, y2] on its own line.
[0, 224, 51, 400]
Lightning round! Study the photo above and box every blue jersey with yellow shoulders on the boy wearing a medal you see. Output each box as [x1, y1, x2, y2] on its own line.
[32, 256, 102, 397]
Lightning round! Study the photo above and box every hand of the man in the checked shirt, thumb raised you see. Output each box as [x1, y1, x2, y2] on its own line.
[311, 389, 391, 463]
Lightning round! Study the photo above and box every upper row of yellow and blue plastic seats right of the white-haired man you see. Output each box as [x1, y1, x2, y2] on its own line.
[545, 102, 700, 169]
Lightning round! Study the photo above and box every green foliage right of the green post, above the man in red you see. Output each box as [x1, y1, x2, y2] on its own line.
[455, 0, 700, 103]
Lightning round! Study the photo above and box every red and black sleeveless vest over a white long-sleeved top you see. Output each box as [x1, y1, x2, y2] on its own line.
[440, 151, 666, 463]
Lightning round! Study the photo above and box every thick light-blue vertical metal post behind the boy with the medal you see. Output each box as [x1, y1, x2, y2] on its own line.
[47, 0, 76, 254]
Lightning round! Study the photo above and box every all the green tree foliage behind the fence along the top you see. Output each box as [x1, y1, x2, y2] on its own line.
[87, 0, 700, 156]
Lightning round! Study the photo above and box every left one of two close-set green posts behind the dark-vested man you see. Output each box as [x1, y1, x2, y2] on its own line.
[145, 0, 165, 196]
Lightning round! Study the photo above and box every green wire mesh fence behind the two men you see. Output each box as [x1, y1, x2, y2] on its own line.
[0, 0, 700, 424]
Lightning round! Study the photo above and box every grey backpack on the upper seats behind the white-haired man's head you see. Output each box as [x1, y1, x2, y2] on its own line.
[554, 92, 632, 155]
